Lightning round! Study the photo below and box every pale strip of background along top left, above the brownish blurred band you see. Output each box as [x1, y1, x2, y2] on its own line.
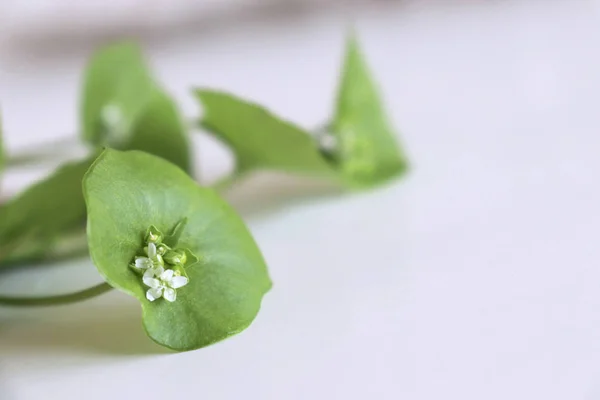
[0, 0, 342, 42]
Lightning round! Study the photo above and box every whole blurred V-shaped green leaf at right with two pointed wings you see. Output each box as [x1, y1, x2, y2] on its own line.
[195, 36, 408, 188]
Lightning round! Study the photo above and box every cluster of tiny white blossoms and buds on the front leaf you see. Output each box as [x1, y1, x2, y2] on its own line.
[131, 229, 188, 302]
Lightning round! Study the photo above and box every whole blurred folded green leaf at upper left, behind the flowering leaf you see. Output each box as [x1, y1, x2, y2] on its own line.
[82, 42, 192, 172]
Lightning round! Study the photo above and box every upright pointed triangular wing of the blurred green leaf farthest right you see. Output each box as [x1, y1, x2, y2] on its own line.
[329, 35, 408, 187]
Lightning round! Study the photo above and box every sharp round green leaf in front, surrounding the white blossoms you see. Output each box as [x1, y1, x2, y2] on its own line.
[84, 149, 271, 351]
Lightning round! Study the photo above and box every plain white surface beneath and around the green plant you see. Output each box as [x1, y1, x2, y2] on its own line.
[0, 1, 600, 400]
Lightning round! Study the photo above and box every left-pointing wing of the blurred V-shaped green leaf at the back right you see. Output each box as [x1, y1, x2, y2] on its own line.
[195, 90, 331, 174]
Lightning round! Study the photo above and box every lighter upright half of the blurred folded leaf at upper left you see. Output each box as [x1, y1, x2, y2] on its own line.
[81, 42, 156, 147]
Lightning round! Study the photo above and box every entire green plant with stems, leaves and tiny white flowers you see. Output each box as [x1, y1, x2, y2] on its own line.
[0, 35, 407, 351]
